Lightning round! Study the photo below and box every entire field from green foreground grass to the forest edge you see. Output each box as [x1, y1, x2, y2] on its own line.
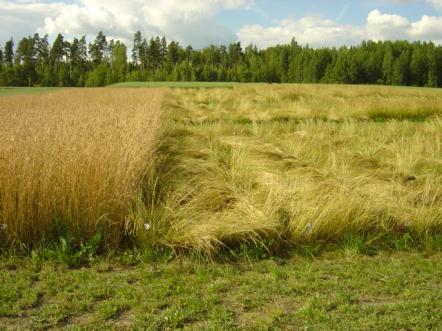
[0, 83, 442, 330]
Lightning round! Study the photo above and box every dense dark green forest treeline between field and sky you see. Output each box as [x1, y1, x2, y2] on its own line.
[0, 32, 442, 87]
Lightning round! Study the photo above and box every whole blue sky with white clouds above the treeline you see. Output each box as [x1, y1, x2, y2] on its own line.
[0, 0, 442, 47]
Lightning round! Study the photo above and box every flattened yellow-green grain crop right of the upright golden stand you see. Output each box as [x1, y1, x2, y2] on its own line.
[150, 85, 442, 253]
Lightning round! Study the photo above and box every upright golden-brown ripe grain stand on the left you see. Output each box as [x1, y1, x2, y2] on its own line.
[0, 89, 163, 247]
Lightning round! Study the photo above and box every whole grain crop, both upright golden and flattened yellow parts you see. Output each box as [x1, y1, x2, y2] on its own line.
[0, 85, 442, 255]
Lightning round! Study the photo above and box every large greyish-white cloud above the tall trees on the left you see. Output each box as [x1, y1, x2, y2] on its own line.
[0, 0, 253, 46]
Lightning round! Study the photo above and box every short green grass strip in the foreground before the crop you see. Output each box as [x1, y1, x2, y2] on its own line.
[0, 249, 442, 330]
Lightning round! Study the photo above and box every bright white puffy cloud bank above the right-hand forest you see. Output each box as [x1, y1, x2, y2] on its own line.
[237, 9, 442, 47]
